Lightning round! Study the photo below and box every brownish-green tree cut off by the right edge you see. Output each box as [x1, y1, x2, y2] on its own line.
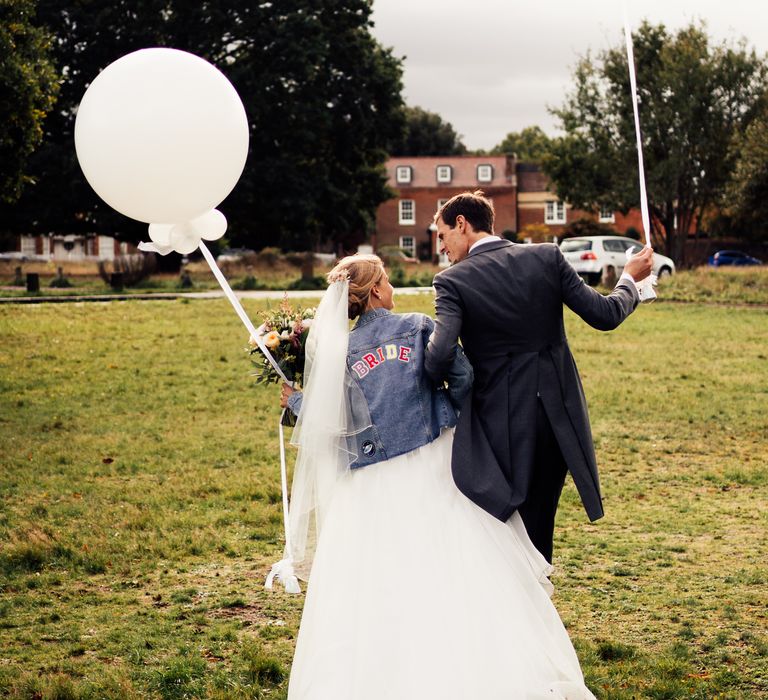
[723, 105, 768, 238]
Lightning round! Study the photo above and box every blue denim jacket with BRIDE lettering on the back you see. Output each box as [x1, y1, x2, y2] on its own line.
[288, 309, 473, 469]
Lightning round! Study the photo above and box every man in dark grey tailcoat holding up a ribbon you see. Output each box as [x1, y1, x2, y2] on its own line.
[425, 191, 653, 562]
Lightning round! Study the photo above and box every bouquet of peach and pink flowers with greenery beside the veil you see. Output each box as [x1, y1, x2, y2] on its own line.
[248, 295, 315, 422]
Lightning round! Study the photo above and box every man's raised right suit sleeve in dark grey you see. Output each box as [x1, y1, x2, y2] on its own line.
[553, 246, 640, 331]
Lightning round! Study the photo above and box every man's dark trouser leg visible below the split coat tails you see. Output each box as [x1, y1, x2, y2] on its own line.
[517, 399, 568, 563]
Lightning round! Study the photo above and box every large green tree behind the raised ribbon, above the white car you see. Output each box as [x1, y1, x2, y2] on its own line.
[543, 22, 766, 263]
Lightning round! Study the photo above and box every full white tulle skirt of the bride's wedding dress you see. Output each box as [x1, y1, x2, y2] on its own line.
[288, 431, 594, 700]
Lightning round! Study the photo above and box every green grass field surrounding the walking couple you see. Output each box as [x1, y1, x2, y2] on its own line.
[0, 295, 768, 700]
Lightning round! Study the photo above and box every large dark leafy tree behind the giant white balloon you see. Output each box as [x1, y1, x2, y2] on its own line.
[2, 0, 403, 248]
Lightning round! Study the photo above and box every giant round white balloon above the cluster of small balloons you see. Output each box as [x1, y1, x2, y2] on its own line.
[75, 48, 248, 224]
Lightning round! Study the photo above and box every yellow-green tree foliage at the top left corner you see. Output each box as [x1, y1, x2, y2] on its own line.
[0, 0, 58, 204]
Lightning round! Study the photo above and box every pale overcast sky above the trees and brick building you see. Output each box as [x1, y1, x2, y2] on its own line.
[373, 0, 768, 149]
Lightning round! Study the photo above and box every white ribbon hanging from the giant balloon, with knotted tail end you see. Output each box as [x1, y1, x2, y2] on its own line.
[195, 241, 301, 593]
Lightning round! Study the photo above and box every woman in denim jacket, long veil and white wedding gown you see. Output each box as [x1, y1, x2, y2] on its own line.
[278, 255, 594, 700]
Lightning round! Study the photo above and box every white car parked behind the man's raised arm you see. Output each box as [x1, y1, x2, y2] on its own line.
[560, 236, 675, 284]
